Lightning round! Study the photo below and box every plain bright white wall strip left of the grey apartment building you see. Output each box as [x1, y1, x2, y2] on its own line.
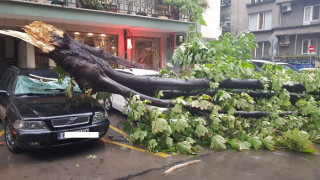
[201, 0, 221, 39]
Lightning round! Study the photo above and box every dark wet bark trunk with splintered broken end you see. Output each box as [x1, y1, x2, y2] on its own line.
[0, 21, 318, 107]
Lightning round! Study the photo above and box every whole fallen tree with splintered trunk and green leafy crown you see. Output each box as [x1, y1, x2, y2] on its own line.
[0, 22, 320, 153]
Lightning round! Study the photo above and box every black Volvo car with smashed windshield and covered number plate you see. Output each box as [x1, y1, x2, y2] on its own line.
[0, 67, 110, 153]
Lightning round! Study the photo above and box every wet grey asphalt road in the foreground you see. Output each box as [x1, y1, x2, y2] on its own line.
[0, 112, 320, 180]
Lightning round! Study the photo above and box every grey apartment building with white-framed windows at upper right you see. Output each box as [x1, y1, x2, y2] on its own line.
[221, 0, 320, 59]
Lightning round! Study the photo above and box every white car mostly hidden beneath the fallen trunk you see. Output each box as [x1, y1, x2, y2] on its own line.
[106, 68, 167, 113]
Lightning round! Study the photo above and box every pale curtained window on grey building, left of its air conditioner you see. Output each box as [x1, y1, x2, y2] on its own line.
[249, 11, 272, 31]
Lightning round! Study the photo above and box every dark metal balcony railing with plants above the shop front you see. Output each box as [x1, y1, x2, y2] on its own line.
[16, 0, 190, 21]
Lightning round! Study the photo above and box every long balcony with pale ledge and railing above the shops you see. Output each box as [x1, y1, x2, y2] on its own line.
[0, 0, 191, 33]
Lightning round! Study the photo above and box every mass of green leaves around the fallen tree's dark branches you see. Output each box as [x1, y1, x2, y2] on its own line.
[125, 32, 320, 154]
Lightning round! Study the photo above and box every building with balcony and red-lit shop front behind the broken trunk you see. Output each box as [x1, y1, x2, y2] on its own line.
[0, 0, 221, 74]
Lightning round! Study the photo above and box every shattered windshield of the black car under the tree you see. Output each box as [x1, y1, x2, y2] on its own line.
[15, 75, 82, 95]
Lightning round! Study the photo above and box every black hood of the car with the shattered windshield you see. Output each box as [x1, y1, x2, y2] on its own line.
[15, 97, 103, 119]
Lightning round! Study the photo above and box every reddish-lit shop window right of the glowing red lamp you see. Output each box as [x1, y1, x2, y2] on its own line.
[133, 38, 161, 70]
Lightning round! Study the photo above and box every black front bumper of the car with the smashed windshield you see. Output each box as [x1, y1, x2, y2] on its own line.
[16, 120, 110, 149]
